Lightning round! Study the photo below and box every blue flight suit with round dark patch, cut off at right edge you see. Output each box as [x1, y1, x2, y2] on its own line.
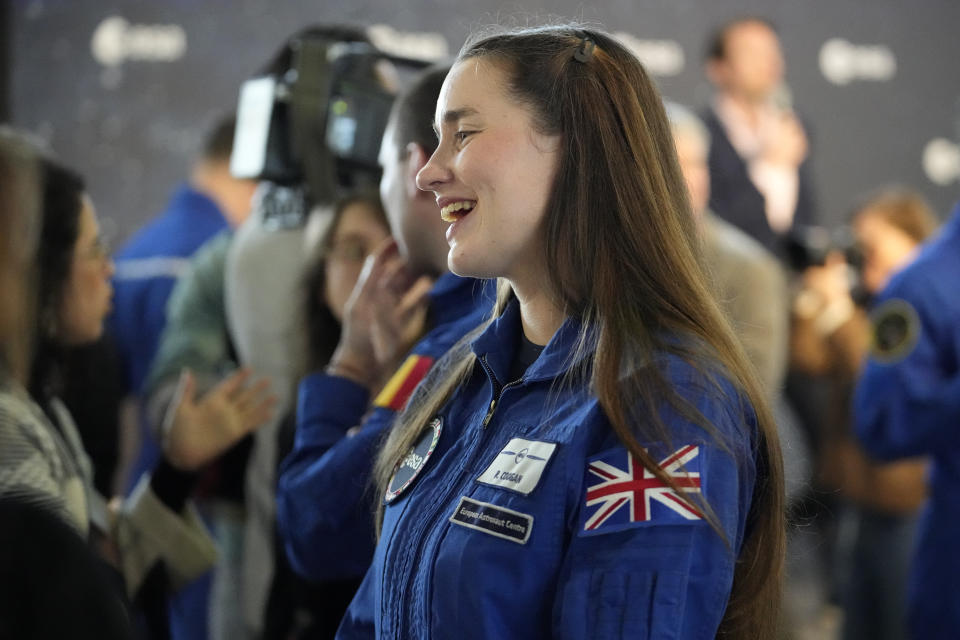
[854, 206, 960, 638]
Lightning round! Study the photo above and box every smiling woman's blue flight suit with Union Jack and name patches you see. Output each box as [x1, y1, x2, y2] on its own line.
[337, 301, 758, 640]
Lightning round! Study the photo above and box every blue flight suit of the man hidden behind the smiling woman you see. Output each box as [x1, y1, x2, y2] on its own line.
[277, 273, 494, 582]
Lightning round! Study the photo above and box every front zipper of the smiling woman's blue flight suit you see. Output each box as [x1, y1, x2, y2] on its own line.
[393, 356, 523, 638]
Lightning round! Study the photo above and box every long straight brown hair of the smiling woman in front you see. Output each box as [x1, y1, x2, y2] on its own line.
[376, 26, 785, 638]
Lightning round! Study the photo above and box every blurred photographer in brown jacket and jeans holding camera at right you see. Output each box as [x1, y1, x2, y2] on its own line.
[791, 189, 936, 638]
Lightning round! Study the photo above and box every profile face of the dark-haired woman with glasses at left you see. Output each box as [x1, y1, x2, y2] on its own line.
[58, 196, 113, 345]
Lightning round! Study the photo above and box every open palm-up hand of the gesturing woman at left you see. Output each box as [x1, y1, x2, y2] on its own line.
[162, 368, 277, 471]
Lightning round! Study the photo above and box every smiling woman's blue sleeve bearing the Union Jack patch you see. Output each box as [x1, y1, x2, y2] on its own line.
[553, 394, 756, 640]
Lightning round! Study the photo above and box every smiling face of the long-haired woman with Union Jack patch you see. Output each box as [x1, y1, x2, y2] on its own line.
[417, 59, 559, 284]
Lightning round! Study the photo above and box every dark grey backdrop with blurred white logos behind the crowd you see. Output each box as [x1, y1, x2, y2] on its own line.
[7, 0, 960, 241]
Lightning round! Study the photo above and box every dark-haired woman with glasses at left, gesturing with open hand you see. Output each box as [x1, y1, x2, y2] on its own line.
[0, 145, 272, 620]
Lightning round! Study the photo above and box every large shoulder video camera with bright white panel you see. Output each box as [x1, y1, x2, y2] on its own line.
[230, 33, 427, 215]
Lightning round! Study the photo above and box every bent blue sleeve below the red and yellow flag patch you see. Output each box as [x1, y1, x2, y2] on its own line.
[277, 374, 386, 582]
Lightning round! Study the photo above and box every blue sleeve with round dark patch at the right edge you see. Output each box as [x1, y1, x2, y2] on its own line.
[854, 272, 960, 459]
